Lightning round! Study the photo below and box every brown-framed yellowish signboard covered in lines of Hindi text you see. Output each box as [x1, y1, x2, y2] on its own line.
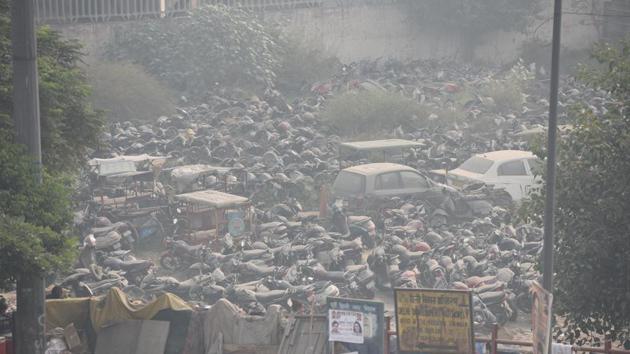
[394, 289, 475, 354]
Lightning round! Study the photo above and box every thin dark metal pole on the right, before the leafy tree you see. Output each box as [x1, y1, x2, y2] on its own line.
[543, 0, 562, 353]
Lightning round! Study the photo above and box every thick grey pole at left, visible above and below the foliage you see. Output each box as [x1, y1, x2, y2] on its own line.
[11, 0, 46, 354]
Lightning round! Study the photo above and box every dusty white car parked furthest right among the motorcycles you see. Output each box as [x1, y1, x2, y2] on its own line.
[431, 150, 542, 201]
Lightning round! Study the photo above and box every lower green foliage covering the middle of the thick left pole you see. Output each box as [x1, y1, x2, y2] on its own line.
[0, 132, 75, 288]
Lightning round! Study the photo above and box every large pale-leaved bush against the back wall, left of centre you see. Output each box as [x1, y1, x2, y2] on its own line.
[108, 5, 279, 97]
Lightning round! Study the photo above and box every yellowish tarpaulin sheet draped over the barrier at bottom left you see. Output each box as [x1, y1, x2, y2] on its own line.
[46, 288, 192, 332]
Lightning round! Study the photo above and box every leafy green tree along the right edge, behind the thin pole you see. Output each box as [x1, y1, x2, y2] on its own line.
[528, 41, 630, 342]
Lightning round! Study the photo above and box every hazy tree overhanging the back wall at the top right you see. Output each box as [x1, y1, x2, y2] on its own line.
[402, 0, 541, 59]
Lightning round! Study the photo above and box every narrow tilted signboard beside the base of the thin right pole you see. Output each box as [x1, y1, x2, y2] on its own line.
[530, 282, 553, 354]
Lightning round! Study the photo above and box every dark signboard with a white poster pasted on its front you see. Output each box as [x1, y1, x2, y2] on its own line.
[326, 297, 385, 354]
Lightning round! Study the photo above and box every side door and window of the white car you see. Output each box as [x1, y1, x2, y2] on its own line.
[488, 159, 533, 200]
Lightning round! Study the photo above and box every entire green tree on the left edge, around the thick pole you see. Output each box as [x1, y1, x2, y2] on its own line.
[0, 0, 94, 288]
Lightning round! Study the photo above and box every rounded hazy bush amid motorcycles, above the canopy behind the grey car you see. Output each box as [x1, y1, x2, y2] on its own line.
[323, 91, 428, 137]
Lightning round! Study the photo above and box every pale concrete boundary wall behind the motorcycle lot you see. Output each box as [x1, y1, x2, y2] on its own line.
[57, 0, 606, 64]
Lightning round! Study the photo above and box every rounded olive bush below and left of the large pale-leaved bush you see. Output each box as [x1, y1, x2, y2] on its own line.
[88, 62, 175, 120]
